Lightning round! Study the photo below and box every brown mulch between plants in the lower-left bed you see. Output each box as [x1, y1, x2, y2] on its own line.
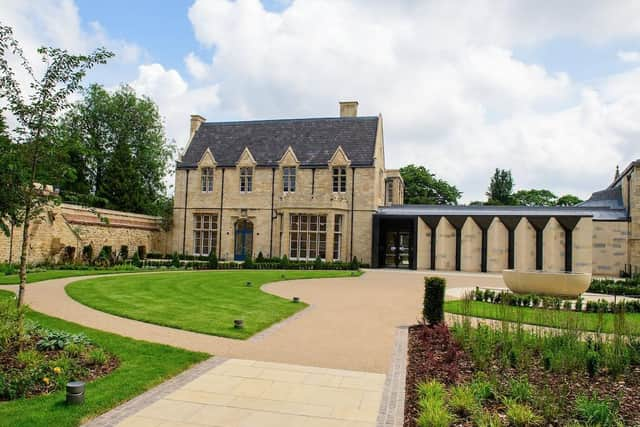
[0, 335, 120, 402]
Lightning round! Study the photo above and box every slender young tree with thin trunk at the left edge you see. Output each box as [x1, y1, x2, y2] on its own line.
[0, 24, 113, 306]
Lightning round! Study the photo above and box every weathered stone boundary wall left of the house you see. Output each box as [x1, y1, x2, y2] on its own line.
[0, 203, 170, 264]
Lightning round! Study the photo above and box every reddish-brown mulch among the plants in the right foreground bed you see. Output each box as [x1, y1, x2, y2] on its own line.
[404, 325, 640, 427]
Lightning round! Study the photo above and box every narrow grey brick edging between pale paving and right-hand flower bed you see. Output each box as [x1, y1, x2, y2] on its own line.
[376, 326, 409, 427]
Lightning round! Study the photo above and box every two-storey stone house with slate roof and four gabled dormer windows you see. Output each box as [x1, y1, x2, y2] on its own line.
[172, 102, 403, 262]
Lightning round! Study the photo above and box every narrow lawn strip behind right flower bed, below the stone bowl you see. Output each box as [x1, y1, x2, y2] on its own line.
[444, 300, 640, 335]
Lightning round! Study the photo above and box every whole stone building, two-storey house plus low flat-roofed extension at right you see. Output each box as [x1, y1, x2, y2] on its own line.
[171, 102, 640, 275]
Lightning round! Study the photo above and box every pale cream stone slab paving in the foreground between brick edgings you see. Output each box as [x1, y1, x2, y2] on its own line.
[110, 358, 386, 427]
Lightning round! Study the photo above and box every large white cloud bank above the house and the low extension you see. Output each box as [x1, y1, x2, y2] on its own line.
[189, 0, 640, 201]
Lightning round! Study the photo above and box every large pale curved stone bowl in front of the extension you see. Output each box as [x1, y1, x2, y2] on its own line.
[502, 270, 591, 298]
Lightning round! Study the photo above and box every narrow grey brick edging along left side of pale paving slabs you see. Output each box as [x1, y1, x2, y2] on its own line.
[83, 356, 227, 427]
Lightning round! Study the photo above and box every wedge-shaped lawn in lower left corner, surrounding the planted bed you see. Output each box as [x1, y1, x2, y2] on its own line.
[0, 291, 209, 427]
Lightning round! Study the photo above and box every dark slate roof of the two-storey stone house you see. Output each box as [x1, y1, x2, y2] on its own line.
[177, 117, 379, 168]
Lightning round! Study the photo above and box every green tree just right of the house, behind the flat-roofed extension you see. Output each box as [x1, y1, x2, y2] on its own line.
[400, 165, 462, 205]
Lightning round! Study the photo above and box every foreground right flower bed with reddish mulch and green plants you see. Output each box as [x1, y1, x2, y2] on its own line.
[405, 324, 640, 427]
